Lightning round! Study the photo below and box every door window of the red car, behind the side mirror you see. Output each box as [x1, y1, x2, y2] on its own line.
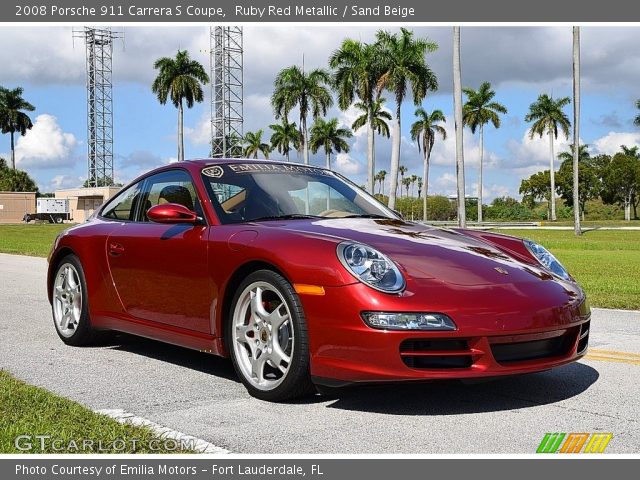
[141, 170, 202, 222]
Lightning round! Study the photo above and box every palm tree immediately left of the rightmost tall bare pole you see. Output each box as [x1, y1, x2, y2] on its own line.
[524, 94, 571, 221]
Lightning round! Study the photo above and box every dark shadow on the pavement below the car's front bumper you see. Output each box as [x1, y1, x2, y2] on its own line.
[327, 363, 599, 416]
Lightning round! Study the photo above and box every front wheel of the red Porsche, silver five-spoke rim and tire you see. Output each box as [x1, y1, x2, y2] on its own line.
[226, 270, 315, 401]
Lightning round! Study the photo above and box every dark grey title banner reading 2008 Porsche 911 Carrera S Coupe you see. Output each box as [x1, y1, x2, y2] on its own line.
[0, 0, 640, 24]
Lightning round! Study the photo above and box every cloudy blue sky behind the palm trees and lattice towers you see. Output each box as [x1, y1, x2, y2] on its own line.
[0, 24, 640, 202]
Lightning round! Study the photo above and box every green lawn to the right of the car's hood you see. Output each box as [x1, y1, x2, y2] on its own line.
[498, 230, 640, 309]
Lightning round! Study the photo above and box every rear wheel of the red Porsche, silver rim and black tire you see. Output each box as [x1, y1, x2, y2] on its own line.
[49, 255, 97, 346]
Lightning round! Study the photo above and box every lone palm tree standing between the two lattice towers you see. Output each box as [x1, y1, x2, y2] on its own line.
[151, 50, 209, 162]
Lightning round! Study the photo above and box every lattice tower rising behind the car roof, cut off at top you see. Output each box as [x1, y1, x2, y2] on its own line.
[209, 26, 243, 158]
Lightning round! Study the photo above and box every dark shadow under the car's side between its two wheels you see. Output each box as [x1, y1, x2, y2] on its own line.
[96, 333, 240, 383]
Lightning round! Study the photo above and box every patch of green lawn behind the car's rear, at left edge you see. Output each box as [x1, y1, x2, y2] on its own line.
[0, 223, 70, 257]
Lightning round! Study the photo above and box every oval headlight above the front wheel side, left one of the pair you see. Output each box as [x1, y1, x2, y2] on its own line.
[338, 242, 404, 293]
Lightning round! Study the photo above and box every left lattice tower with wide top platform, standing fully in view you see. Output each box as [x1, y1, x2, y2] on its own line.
[73, 27, 123, 187]
